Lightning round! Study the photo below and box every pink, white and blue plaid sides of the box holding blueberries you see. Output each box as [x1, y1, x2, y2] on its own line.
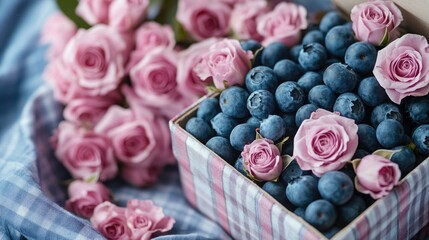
[170, 94, 429, 240]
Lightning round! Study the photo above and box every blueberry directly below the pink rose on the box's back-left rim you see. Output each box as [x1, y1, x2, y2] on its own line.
[219, 86, 250, 118]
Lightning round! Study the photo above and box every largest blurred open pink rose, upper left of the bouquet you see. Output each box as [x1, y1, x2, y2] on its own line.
[63, 25, 127, 96]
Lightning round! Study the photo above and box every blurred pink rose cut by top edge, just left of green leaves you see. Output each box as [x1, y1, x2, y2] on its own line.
[109, 0, 149, 31]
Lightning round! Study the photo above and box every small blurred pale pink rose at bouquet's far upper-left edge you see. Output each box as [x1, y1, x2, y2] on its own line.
[41, 12, 77, 60]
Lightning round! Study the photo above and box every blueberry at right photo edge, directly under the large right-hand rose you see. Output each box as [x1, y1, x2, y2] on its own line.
[405, 97, 429, 125]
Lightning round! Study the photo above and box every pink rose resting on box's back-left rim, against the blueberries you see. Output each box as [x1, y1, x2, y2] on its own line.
[194, 39, 253, 89]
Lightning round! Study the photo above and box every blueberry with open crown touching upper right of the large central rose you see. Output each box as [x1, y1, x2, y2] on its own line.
[333, 93, 365, 124]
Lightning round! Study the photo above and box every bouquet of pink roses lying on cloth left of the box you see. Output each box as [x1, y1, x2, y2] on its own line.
[42, 0, 307, 239]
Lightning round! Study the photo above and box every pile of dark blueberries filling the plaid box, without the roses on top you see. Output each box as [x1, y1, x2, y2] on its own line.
[185, 11, 429, 237]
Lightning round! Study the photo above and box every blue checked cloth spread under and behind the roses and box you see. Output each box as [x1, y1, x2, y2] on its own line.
[0, 0, 330, 239]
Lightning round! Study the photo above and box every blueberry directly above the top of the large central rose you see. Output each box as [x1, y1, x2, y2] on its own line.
[308, 85, 337, 111]
